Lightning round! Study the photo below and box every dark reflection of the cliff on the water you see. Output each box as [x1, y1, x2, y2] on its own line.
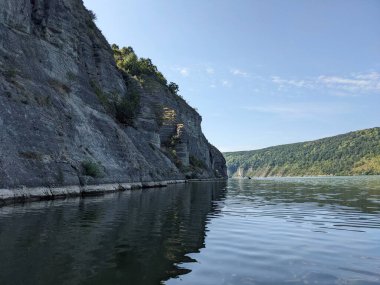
[0, 182, 226, 285]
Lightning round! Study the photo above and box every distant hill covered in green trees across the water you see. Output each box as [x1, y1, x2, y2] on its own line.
[224, 128, 380, 177]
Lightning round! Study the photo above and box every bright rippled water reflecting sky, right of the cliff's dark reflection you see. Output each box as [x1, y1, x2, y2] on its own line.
[167, 177, 380, 285]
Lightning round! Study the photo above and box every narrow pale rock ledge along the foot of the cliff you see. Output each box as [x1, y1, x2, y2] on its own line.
[0, 179, 225, 207]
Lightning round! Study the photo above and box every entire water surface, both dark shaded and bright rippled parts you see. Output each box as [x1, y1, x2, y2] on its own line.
[0, 176, 380, 285]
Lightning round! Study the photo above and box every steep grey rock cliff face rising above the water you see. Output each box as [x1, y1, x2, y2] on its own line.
[0, 0, 226, 188]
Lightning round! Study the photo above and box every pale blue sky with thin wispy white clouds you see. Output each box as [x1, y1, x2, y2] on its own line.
[84, 0, 380, 151]
